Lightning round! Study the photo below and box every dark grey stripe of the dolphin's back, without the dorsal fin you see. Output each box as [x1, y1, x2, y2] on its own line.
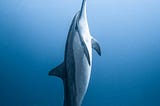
[63, 12, 80, 106]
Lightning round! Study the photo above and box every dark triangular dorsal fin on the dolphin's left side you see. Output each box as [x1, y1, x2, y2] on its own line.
[48, 62, 65, 80]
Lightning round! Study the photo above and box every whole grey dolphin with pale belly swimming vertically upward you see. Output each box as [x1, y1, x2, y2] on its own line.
[48, 0, 101, 106]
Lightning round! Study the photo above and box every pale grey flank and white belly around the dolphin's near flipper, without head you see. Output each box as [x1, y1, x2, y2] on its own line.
[73, 30, 92, 102]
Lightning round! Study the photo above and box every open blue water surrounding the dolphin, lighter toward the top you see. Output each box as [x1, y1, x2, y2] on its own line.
[0, 0, 160, 106]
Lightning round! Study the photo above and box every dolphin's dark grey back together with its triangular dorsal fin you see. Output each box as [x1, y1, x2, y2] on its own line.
[49, 12, 79, 106]
